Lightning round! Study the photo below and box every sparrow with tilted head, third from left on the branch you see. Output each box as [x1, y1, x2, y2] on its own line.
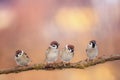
[60, 44, 74, 63]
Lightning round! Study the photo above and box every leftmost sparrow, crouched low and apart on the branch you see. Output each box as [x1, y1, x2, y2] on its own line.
[15, 50, 31, 66]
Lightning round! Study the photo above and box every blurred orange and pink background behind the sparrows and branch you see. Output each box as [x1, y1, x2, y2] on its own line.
[0, 0, 120, 80]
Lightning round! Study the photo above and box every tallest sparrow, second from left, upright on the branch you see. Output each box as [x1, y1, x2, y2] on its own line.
[45, 41, 60, 64]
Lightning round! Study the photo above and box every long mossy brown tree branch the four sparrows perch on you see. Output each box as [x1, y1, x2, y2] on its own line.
[0, 54, 120, 74]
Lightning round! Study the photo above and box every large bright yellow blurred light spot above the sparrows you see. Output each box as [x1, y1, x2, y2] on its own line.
[55, 7, 98, 31]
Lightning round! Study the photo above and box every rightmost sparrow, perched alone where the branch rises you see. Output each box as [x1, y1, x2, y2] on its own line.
[86, 40, 98, 60]
